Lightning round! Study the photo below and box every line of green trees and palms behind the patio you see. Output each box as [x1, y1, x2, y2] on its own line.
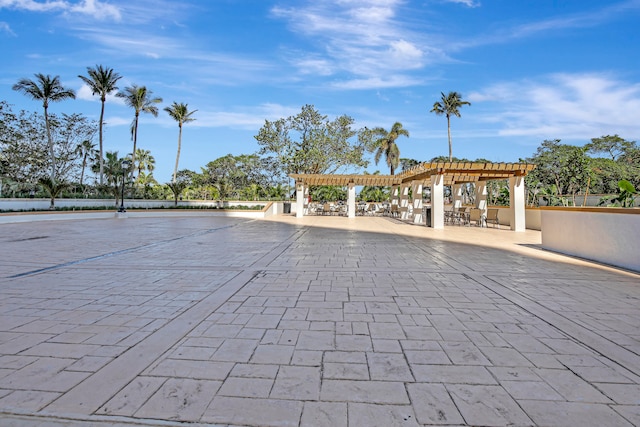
[0, 77, 640, 209]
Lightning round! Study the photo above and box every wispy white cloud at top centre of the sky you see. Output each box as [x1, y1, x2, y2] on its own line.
[272, 0, 430, 88]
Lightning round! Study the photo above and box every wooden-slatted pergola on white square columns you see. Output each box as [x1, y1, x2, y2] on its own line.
[291, 162, 535, 231]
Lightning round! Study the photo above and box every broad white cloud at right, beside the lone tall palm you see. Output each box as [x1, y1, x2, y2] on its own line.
[468, 74, 640, 140]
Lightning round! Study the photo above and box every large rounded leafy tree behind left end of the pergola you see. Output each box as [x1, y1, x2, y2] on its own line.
[254, 105, 368, 183]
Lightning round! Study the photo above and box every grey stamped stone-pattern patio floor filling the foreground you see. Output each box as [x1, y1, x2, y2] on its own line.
[0, 217, 640, 427]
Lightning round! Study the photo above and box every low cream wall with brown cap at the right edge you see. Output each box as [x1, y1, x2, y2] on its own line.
[540, 207, 640, 271]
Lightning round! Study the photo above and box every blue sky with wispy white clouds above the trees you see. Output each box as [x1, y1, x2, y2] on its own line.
[0, 0, 640, 182]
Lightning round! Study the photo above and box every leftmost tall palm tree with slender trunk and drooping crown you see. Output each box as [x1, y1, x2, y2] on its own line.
[12, 73, 76, 185]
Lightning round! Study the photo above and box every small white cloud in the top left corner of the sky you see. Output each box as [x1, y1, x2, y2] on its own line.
[0, 0, 121, 21]
